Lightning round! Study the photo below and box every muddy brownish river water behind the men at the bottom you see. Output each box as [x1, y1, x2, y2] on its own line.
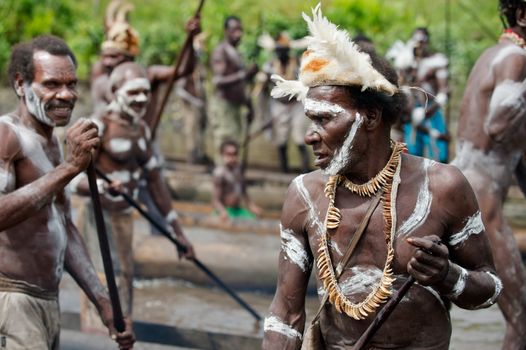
[135, 279, 504, 350]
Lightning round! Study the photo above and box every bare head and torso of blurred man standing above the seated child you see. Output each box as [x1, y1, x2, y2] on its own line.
[212, 19, 258, 117]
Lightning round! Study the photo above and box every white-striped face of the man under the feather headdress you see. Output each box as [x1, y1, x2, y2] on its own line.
[304, 86, 363, 175]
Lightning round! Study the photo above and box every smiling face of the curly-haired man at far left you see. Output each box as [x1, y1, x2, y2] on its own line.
[24, 51, 78, 127]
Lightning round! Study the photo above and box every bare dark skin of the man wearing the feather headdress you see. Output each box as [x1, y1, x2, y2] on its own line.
[263, 86, 502, 349]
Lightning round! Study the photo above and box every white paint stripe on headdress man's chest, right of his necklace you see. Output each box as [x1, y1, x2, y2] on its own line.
[398, 159, 434, 237]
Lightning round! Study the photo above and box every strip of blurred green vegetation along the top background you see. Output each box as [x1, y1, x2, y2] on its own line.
[0, 0, 502, 109]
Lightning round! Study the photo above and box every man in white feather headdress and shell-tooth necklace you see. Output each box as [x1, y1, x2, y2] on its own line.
[263, 7, 501, 350]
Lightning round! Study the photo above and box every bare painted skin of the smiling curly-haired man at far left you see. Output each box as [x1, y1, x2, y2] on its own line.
[0, 51, 135, 349]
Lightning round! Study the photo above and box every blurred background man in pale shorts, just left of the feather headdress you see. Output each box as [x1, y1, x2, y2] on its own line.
[263, 32, 309, 173]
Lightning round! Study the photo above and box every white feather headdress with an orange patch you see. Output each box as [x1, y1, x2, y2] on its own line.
[271, 4, 398, 101]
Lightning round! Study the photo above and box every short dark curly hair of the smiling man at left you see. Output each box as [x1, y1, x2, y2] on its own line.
[7, 35, 77, 88]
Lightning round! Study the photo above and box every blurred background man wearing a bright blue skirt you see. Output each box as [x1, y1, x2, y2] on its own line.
[404, 28, 449, 163]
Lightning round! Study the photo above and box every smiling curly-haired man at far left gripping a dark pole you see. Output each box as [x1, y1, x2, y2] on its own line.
[0, 36, 134, 349]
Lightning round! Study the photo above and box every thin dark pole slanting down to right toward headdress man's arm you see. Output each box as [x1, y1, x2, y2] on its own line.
[95, 165, 261, 321]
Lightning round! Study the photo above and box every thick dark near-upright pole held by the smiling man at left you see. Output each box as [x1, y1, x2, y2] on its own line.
[87, 162, 125, 332]
